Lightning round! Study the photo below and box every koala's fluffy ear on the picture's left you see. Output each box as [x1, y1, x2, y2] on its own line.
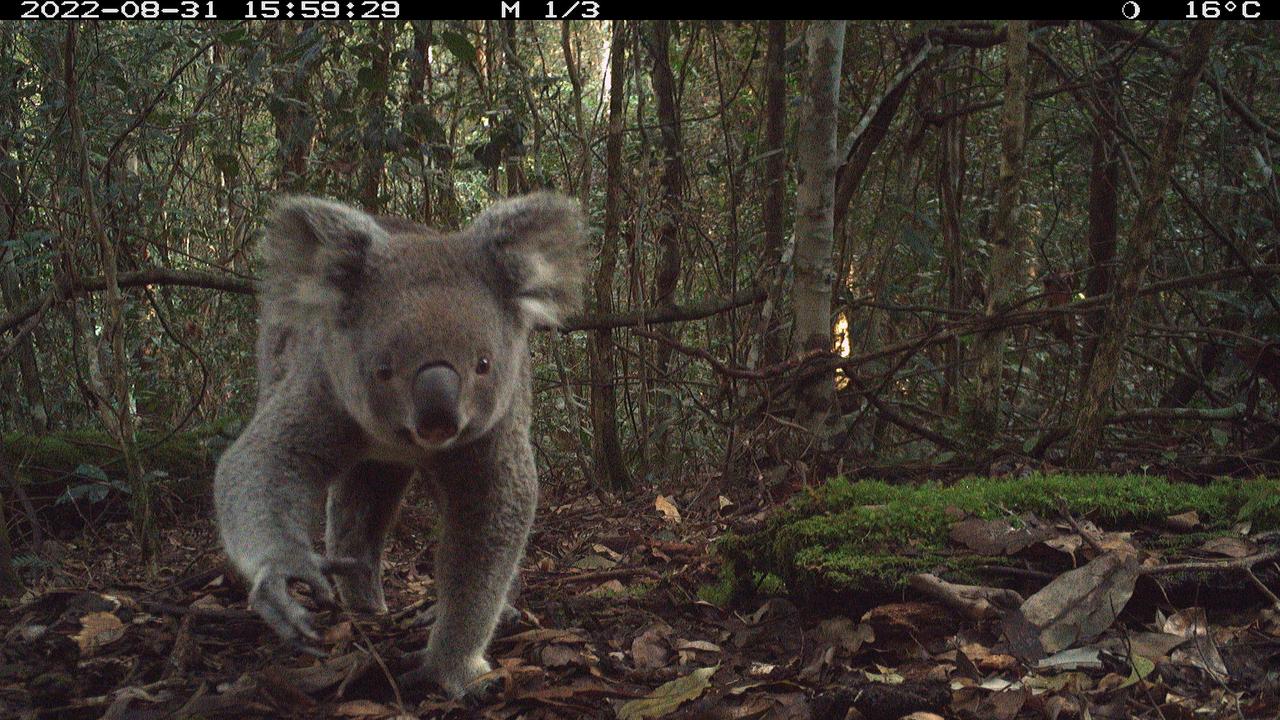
[261, 197, 387, 313]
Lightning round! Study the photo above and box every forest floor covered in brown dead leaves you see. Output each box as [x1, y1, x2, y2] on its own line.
[0, 471, 1280, 720]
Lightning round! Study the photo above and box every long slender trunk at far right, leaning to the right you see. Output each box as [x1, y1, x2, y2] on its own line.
[1066, 22, 1213, 468]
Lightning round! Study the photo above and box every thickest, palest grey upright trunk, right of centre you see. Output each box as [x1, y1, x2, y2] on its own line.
[791, 20, 845, 438]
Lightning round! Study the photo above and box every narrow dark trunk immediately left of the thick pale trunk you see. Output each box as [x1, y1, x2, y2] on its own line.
[746, 20, 787, 368]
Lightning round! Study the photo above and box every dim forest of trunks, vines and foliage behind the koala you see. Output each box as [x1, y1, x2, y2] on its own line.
[0, 20, 1280, 717]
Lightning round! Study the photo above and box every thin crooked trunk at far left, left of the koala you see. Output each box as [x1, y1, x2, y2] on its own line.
[63, 23, 160, 571]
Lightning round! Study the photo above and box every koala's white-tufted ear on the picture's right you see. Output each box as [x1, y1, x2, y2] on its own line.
[470, 192, 586, 328]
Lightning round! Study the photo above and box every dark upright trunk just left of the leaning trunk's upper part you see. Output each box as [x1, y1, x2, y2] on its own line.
[1084, 29, 1121, 366]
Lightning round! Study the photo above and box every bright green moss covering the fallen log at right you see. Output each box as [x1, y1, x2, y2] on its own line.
[708, 475, 1280, 598]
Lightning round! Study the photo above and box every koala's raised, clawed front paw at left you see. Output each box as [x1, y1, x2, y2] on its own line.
[248, 551, 360, 643]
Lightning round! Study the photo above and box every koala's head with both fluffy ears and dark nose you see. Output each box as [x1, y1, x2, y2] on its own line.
[262, 193, 582, 450]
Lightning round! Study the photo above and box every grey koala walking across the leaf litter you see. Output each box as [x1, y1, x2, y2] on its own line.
[214, 192, 585, 697]
